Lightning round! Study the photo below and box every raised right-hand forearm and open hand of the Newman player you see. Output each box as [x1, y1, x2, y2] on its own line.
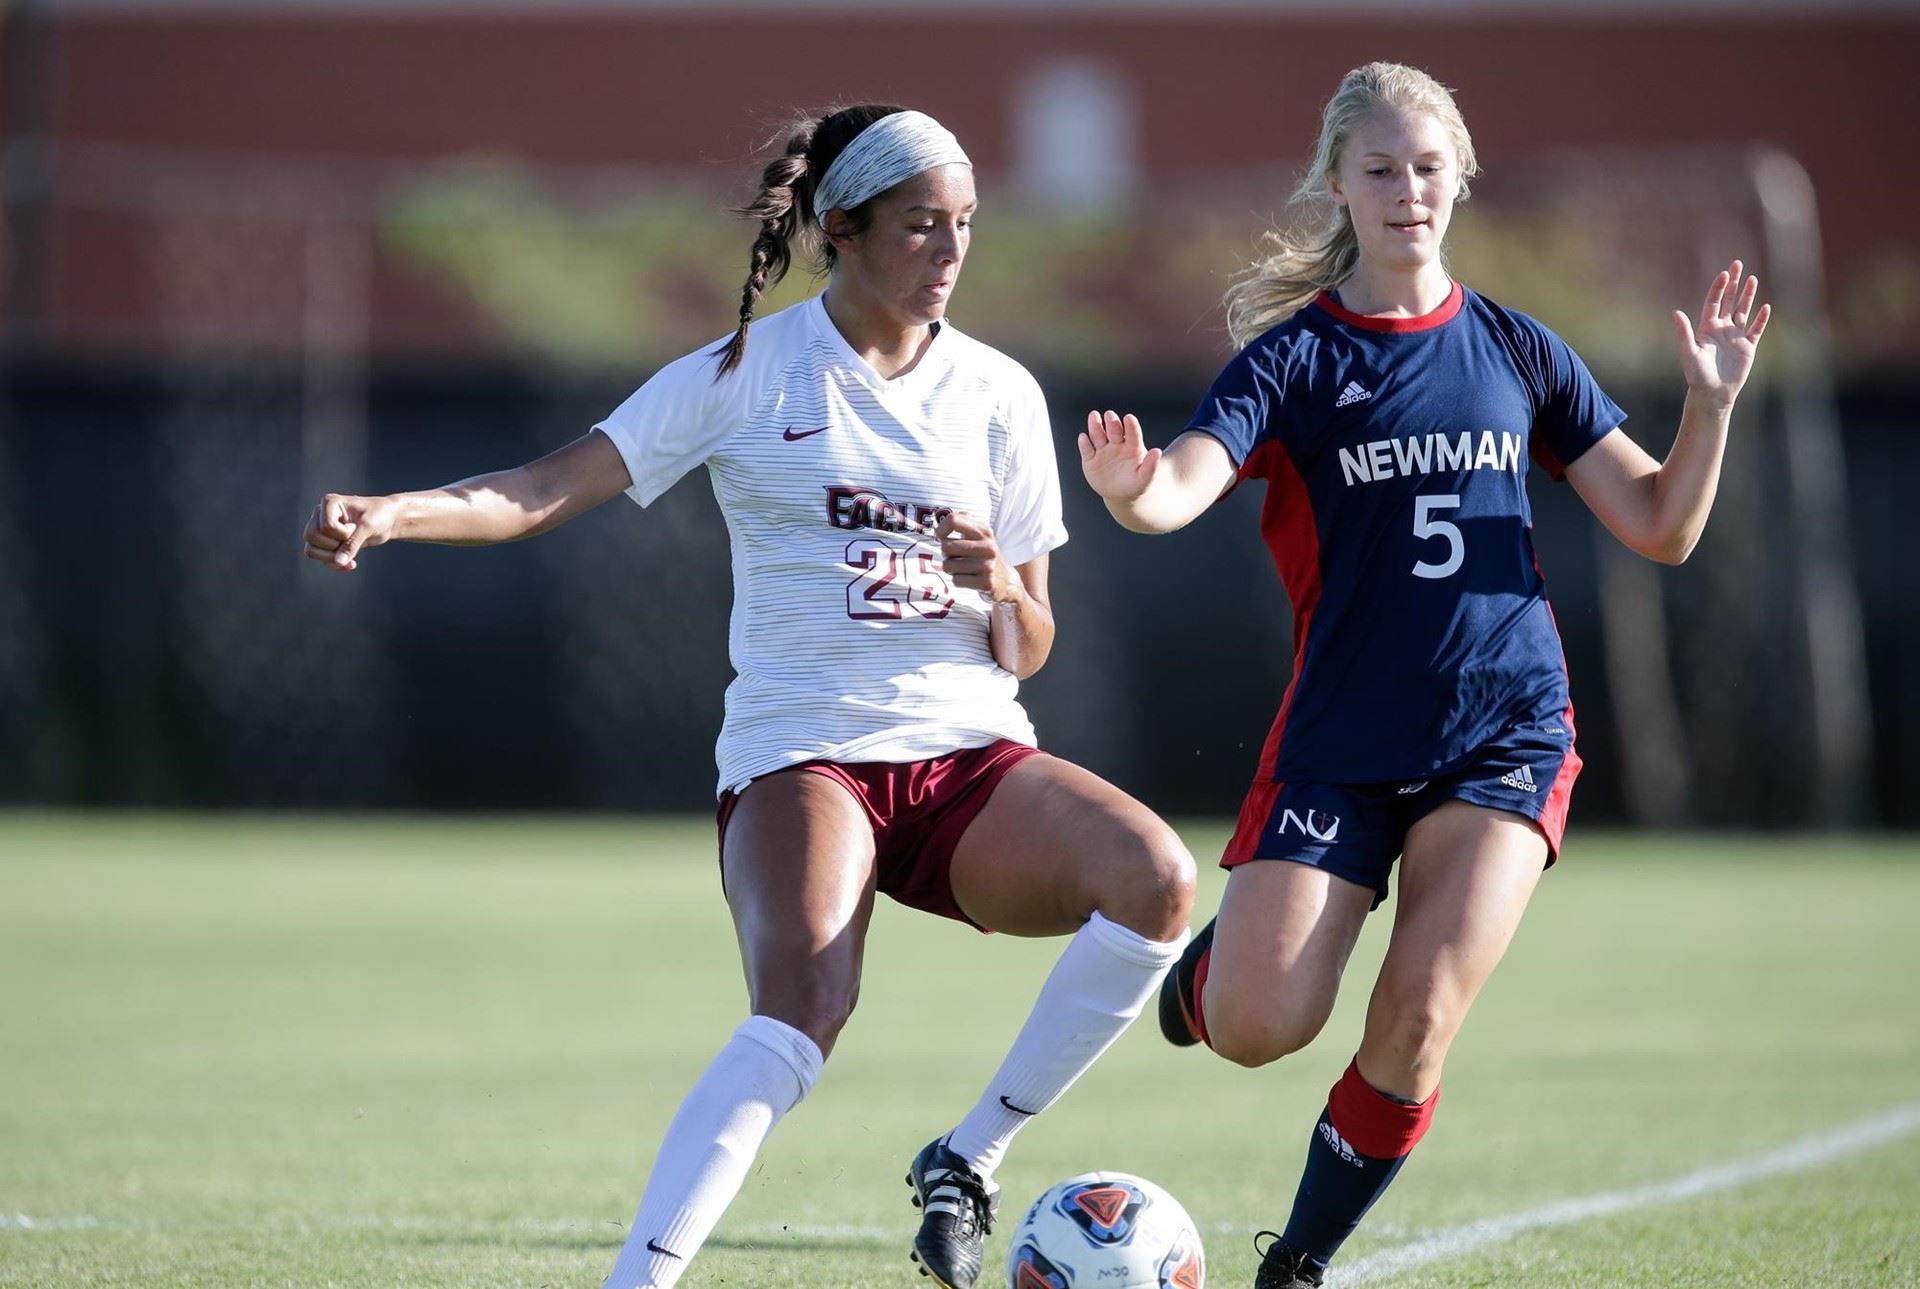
[1567, 259, 1772, 565]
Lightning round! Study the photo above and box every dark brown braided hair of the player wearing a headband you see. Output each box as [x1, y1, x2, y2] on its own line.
[714, 104, 906, 380]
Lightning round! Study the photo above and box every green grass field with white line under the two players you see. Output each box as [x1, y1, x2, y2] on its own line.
[0, 815, 1920, 1289]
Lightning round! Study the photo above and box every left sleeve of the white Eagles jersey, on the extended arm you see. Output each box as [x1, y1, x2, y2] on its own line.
[593, 346, 756, 505]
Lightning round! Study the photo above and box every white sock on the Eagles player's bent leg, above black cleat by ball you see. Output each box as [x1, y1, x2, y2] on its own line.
[947, 912, 1187, 1178]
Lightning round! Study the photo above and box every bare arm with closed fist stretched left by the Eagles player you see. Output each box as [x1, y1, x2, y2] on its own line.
[305, 432, 632, 572]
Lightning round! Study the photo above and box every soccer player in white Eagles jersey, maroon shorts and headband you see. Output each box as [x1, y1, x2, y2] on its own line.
[305, 106, 1194, 1289]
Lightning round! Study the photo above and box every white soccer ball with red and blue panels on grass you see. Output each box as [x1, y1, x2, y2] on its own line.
[1006, 1172, 1206, 1289]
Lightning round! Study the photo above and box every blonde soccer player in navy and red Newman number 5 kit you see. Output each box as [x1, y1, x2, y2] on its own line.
[1079, 63, 1768, 1289]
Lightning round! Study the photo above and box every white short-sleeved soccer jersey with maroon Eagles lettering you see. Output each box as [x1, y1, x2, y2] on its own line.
[595, 296, 1068, 790]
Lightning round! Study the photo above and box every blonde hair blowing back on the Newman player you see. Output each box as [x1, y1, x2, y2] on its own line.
[1225, 63, 1480, 348]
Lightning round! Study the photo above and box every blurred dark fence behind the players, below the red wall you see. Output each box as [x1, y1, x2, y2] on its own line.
[0, 355, 1920, 826]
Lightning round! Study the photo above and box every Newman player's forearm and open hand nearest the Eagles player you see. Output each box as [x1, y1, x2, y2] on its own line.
[1079, 411, 1236, 532]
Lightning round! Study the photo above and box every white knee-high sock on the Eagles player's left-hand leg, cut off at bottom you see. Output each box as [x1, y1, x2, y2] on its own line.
[605, 1016, 824, 1289]
